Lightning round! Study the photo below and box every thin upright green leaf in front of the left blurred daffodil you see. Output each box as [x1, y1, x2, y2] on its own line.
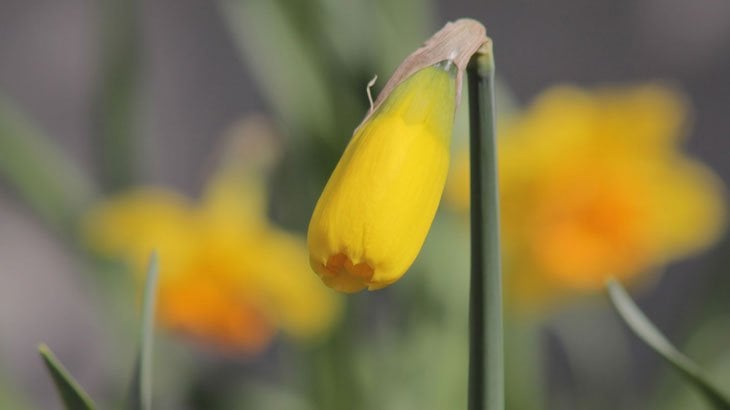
[129, 252, 160, 410]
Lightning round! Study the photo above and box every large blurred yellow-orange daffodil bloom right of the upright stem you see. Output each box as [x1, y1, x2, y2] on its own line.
[447, 85, 724, 306]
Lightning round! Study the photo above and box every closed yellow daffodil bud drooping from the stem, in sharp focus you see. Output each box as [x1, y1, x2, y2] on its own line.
[308, 60, 457, 292]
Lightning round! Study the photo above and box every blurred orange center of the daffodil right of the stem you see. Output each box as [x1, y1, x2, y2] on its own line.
[531, 173, 650, 288]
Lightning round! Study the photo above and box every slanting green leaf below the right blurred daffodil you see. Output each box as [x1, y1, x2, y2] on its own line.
[606, 278, 730, 410]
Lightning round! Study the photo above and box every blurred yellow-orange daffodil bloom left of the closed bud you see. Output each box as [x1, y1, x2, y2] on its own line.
[85, 172, 339, 353]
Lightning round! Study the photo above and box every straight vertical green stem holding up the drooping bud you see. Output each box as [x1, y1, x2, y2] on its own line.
[467, 42, 504, 410]
